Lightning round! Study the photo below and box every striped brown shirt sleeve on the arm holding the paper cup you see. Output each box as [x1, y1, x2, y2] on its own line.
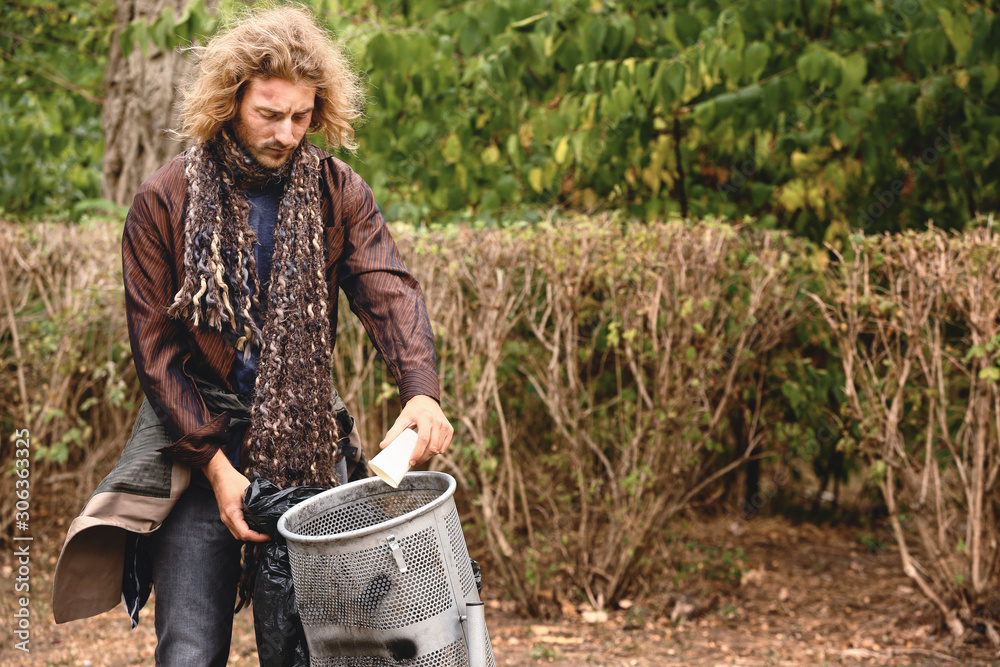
[337, 166, 441, 405]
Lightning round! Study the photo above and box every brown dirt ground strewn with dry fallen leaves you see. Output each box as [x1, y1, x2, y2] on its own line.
[0, 519, 1000, 667]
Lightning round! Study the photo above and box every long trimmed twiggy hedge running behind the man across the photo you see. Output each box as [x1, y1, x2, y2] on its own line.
[0, 217, 1000, 632]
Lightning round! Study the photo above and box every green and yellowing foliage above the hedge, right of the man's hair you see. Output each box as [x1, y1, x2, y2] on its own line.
[320, 0, 1000, 241]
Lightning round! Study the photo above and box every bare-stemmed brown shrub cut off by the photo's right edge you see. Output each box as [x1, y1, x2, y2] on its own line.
[814, 229, 1000, 644]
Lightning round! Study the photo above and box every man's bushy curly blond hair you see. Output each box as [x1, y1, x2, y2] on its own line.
[177, 5, 364, 150]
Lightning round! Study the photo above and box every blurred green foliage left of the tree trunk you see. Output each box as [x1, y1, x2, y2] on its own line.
[0, 0, 113, 214]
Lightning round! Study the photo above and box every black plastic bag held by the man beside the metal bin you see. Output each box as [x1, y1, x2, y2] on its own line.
[241, 479, 325, 667]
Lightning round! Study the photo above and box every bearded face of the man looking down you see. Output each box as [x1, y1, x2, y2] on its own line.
[233, 79, 316, 169]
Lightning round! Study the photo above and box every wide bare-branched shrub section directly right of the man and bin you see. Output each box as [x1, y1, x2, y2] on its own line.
[364, 219, 808, 613]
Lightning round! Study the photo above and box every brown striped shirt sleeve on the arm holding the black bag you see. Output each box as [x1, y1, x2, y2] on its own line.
[122, 180, 229, 467]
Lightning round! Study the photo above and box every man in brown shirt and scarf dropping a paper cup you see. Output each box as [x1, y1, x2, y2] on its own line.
[54, 7, 453, 666]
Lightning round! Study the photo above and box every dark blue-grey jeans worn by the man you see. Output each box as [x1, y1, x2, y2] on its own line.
[149, 478, 241, 667]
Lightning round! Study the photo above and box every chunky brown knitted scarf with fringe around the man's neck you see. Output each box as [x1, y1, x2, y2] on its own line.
[167, 130, 341, 488]
